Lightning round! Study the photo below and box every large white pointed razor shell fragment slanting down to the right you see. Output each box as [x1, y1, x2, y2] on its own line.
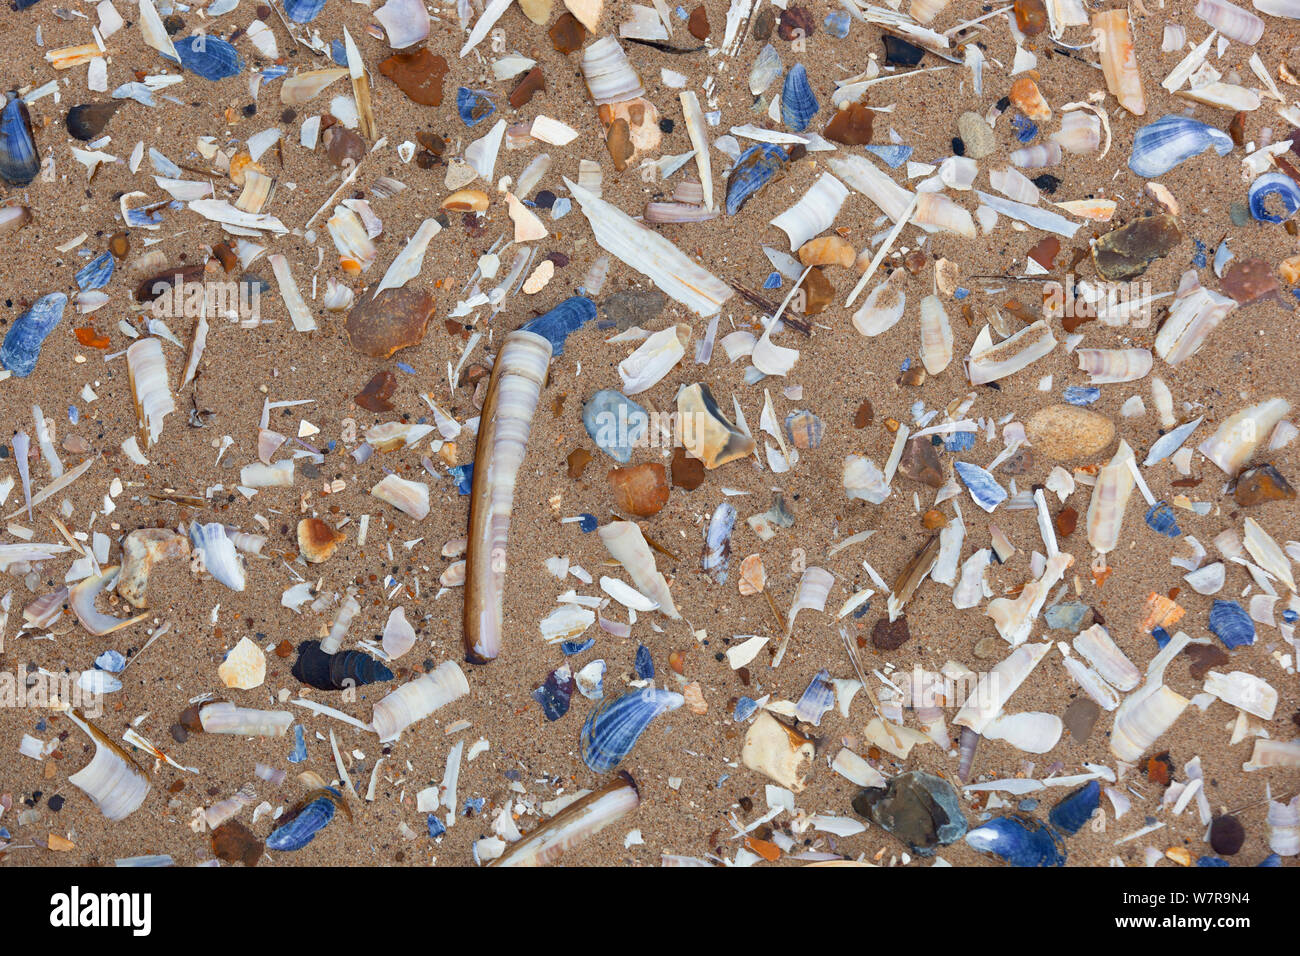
[564, 178, 738, 319]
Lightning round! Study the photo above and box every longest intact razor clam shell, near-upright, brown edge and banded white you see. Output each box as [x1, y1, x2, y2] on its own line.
[464, 330, 551, 663]
